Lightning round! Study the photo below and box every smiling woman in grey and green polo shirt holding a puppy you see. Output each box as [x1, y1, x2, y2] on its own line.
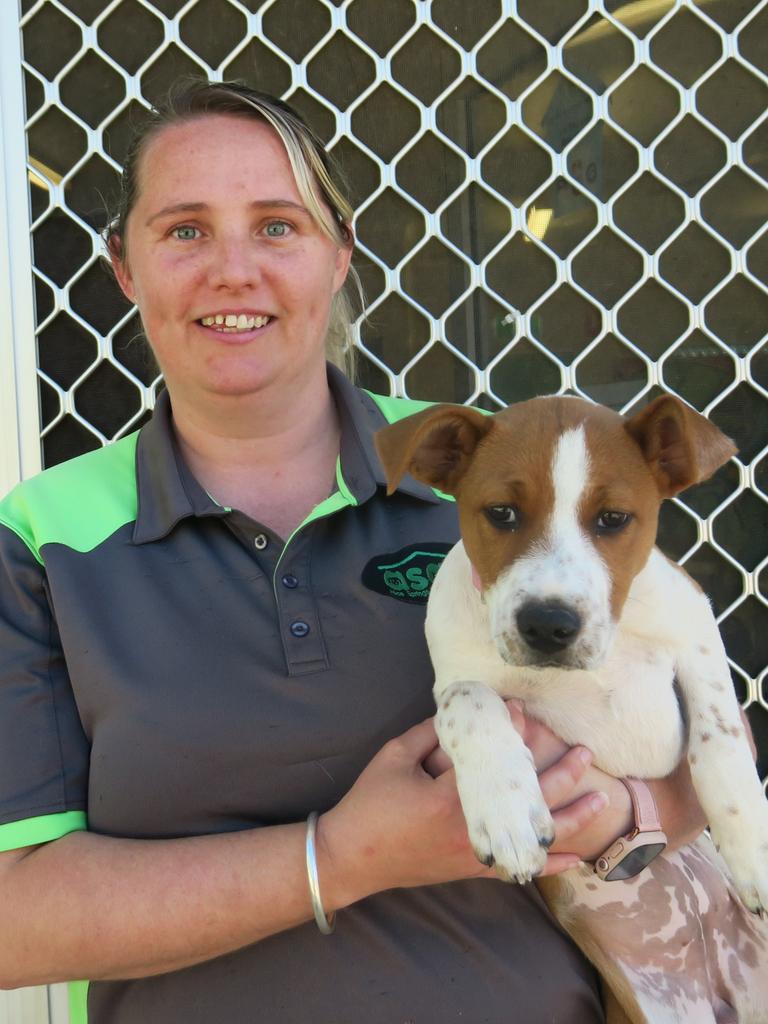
[0, 83, 698, 1024]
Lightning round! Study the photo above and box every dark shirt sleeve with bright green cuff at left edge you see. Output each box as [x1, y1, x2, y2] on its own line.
[0, 523, 89, 851]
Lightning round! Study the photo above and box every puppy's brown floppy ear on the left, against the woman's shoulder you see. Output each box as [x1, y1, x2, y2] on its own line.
[374, 406, 493, 495]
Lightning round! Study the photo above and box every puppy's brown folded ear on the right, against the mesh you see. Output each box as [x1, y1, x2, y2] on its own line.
[626, 395, 737, 498]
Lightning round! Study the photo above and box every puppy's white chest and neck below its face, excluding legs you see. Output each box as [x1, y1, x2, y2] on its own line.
[427, 544, 693, 777]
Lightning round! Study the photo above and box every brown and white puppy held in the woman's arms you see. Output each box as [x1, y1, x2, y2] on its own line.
[377, 396, 768, 1024]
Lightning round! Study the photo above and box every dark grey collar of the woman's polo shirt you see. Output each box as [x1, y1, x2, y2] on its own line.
[133, 365, 439, 544]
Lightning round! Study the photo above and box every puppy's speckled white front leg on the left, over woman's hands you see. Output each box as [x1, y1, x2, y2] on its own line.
[435, 681, 554, 883]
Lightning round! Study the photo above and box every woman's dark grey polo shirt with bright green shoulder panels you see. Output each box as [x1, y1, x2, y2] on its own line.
[0, 369, 602, 1024]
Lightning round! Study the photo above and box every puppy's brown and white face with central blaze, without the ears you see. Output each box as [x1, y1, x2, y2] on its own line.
[457, 398, 659, 669]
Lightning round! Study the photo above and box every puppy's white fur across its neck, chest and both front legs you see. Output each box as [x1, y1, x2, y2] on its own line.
[426, 543, 768, 910]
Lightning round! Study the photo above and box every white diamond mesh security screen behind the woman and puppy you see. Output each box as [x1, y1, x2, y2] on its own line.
[16, 0, 768, 775]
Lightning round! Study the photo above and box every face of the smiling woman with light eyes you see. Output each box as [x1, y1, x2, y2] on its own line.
[114, 115, 350, 402]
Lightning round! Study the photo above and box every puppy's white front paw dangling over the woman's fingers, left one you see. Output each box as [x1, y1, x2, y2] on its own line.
[462, 775, 555, 884]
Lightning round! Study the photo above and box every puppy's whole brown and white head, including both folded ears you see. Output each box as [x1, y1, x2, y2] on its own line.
[376, 395, 736, 669]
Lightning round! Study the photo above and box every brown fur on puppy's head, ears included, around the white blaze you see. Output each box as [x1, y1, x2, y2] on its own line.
[376, 396, 735, 621]
